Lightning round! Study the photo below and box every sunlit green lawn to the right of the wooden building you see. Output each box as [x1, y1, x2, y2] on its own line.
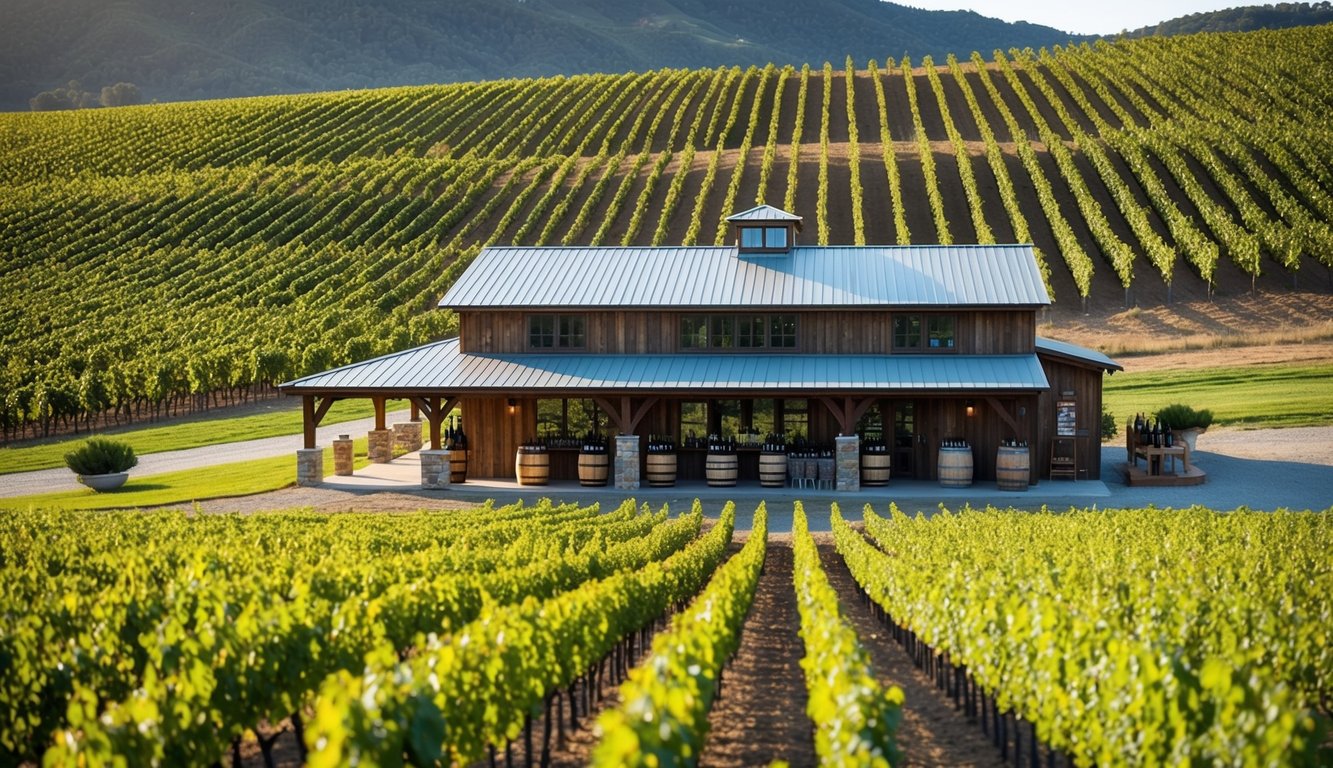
[1104, 364, 1333, 429]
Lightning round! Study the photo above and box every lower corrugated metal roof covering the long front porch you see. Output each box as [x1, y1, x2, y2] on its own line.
[283, 339, 1048, 395]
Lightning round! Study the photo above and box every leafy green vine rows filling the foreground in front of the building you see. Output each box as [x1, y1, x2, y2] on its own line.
[0, 503, 1333, 765]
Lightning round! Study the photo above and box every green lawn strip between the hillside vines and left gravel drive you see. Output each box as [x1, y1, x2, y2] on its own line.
[0, 397, 407, 475]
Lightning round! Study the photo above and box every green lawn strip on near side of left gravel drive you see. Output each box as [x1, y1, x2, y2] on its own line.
[0, 437, 369, 509]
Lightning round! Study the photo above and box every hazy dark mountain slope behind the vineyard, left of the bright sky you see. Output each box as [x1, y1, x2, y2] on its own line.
[0, 0, 1070, 109]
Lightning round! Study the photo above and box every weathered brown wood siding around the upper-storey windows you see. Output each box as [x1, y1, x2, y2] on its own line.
[459, 309, 1037, 355]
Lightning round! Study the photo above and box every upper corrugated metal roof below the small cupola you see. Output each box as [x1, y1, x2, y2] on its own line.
[440, 245, 1050, 309]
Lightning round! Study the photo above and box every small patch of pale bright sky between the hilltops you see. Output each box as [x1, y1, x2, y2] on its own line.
[893, 0, 1261, 35]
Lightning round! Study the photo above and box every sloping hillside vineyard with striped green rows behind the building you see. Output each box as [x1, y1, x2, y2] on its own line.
[0, 27, 1333, 439]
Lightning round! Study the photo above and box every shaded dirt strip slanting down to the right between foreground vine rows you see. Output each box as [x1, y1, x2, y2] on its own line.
[814, 533, 1004, 765]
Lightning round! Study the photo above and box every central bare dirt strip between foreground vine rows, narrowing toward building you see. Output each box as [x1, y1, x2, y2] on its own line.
[698, 536, 816, 767]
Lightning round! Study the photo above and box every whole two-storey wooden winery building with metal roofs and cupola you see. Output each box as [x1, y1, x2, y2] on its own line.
[283, 205, 1120, 489]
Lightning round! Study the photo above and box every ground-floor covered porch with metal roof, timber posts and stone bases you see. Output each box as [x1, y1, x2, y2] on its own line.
[283, 339, 1096, 491]
